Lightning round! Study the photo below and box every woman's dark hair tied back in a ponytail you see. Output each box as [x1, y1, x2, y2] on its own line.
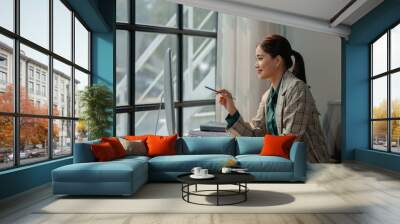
[260, 34, 307, 83]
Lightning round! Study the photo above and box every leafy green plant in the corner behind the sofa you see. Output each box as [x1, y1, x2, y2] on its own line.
[79, 84, 113, 140]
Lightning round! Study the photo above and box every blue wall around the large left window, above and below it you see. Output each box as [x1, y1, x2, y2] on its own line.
[0, 0, 115, 199]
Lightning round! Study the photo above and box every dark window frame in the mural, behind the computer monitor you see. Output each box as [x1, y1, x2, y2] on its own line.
[113, 0, 219, 136]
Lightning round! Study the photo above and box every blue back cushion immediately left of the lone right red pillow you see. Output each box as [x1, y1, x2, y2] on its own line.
[236, 137, 264, 155]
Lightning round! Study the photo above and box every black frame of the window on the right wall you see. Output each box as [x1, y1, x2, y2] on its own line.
[368, 20, 400, 155]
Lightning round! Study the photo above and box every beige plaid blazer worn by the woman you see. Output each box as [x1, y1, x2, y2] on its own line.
[227, 71, 329, 162]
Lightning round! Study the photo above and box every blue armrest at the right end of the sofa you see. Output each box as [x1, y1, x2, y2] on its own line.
[290, 141, 307, 181]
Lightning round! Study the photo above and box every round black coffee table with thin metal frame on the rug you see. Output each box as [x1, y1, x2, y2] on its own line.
[177, 173, 255, 206]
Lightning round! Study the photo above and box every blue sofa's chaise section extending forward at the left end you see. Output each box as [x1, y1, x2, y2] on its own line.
[52, 142, 149, 195]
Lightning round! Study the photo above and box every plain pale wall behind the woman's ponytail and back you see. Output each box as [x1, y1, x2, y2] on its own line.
[284, 27, 341, 121]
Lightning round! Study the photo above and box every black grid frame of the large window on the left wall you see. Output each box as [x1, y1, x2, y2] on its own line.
[0, 0, 93, 172]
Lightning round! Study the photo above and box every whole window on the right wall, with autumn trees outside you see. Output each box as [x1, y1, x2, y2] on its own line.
[370, 22, 400, 153]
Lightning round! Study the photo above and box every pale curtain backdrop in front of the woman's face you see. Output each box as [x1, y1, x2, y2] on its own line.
[216, 14, 282, 121]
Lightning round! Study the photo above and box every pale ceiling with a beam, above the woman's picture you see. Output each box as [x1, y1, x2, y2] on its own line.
[169, 0, 383, 37]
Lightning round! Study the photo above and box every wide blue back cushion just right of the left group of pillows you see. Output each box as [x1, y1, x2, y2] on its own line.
[178, 137, 235, 155]
